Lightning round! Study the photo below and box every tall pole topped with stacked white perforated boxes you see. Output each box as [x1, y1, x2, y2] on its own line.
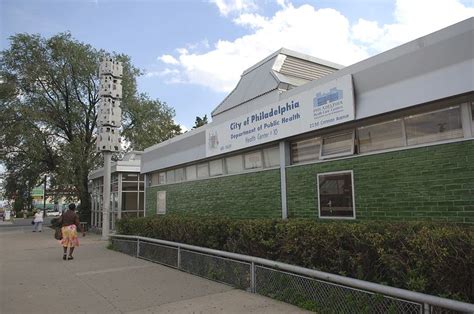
[97, 57, 123, 240]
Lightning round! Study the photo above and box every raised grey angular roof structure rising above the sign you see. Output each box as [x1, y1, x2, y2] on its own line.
[211, 48, 343, 118]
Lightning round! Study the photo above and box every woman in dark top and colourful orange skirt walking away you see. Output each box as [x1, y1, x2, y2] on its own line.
[59, 203, 86, 260]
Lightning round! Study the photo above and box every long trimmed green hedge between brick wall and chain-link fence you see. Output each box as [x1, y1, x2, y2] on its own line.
[118, 215, 474, 303]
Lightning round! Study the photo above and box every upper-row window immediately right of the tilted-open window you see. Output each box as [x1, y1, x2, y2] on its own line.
[357, 119, 404, 153]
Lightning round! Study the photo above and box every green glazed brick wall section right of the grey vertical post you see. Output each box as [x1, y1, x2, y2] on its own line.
[286, 141, 474, 224]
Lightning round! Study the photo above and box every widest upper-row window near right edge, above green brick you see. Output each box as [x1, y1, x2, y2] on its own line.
[405, 106, 463, 145]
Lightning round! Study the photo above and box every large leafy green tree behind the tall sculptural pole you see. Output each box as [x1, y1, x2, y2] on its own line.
[0, 33, 179, 219]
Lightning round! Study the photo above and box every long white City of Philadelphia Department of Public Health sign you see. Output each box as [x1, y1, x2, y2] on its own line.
[206, 74, 354, 157]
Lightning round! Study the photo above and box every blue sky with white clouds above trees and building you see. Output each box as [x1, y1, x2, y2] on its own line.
[0, 0, 474, 130]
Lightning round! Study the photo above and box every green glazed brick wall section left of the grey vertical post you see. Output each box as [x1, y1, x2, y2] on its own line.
[146, 169, 281, 218]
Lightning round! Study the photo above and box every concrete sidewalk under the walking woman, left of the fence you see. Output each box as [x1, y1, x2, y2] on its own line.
[0, 228, 312, 314]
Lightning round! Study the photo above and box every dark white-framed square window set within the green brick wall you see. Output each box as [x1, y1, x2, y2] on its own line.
[318, 171, 355, 218]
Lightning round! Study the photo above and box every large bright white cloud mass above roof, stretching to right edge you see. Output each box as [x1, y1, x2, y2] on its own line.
[151, 0, 474, 92]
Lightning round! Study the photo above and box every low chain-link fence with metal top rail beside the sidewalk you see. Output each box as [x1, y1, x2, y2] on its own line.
[110, 235, 474, 314]
